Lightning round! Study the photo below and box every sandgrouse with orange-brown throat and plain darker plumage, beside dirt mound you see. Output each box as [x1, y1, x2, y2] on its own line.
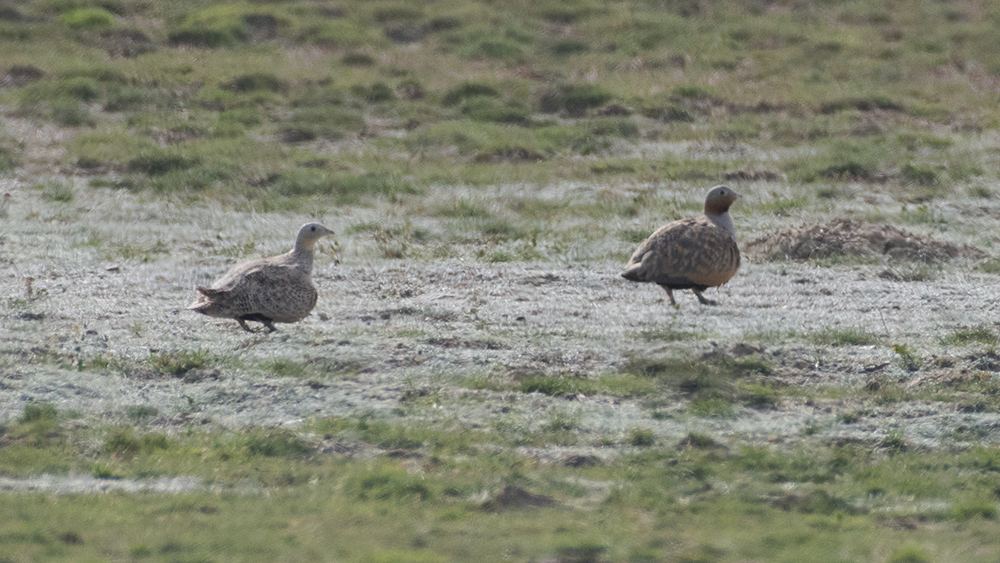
[621, 186, 741, 308]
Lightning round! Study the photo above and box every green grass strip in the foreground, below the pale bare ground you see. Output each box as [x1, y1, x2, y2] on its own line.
[0, 408, 1000, 562]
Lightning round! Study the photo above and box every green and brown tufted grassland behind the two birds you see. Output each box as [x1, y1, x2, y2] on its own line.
[5, 2, 991, 207]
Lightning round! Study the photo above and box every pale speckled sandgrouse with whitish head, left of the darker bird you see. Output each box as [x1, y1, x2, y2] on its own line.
[188, 223, 333, 332]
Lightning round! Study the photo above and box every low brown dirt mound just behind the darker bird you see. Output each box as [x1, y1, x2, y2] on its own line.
[744, 219, 986, 263]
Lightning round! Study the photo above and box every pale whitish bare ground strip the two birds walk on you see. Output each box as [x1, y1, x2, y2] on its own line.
[0, 171, 1000, 468]
